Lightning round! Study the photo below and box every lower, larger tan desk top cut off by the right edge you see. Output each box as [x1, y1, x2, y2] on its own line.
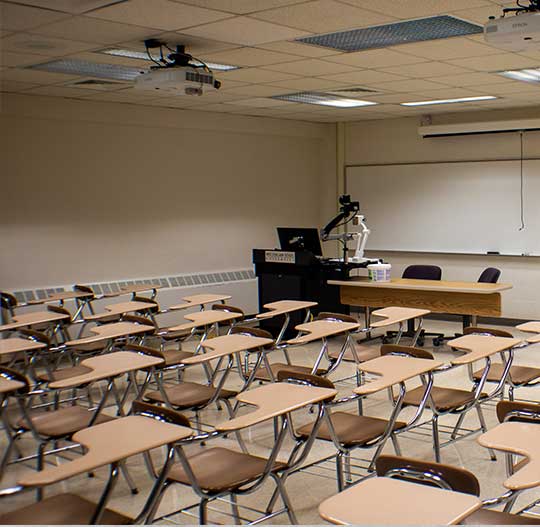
[477, 421, 540, 490]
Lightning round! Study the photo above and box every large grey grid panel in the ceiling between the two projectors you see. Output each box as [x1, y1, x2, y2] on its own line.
[296, 15, 483, 51]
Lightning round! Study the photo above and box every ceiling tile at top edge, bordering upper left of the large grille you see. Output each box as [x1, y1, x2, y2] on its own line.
[249, 0, 395, 33]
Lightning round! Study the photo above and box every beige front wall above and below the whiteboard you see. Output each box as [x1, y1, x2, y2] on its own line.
[346, 108, 540, 319]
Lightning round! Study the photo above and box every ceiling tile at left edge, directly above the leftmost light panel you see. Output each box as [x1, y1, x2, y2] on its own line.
[0, 33, 96, 57]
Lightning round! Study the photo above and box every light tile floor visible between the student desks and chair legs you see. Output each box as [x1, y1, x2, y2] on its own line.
[0, 321, 540, 524]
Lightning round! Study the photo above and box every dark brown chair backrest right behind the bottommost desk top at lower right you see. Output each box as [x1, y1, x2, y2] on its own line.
[375, 455, 480, 496]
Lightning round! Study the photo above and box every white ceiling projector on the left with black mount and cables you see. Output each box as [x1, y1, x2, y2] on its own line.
[134, 39, 221, 95]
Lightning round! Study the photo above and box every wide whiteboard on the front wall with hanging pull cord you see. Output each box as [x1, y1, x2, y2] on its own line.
[346, 160, 540, 255]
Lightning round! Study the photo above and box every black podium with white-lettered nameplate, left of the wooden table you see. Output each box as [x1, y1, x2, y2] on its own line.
[253, 249, 366, 337]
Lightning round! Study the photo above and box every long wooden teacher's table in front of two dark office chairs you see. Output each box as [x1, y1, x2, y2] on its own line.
[328, 277, 512, 325]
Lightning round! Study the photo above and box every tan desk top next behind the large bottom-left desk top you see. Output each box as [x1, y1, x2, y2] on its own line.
[49, 351, 163, 389]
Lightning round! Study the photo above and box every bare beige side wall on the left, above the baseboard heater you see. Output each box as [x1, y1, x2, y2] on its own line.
[0, 95, 335, 290]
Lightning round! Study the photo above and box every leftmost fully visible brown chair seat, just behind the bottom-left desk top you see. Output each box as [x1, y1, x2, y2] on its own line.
[17, 406, 116, 438]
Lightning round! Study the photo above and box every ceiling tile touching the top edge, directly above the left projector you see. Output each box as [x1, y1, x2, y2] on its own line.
[88, 0, 230, 31]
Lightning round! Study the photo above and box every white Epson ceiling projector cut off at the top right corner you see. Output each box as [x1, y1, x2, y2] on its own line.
[484, 0, 540, 51]
